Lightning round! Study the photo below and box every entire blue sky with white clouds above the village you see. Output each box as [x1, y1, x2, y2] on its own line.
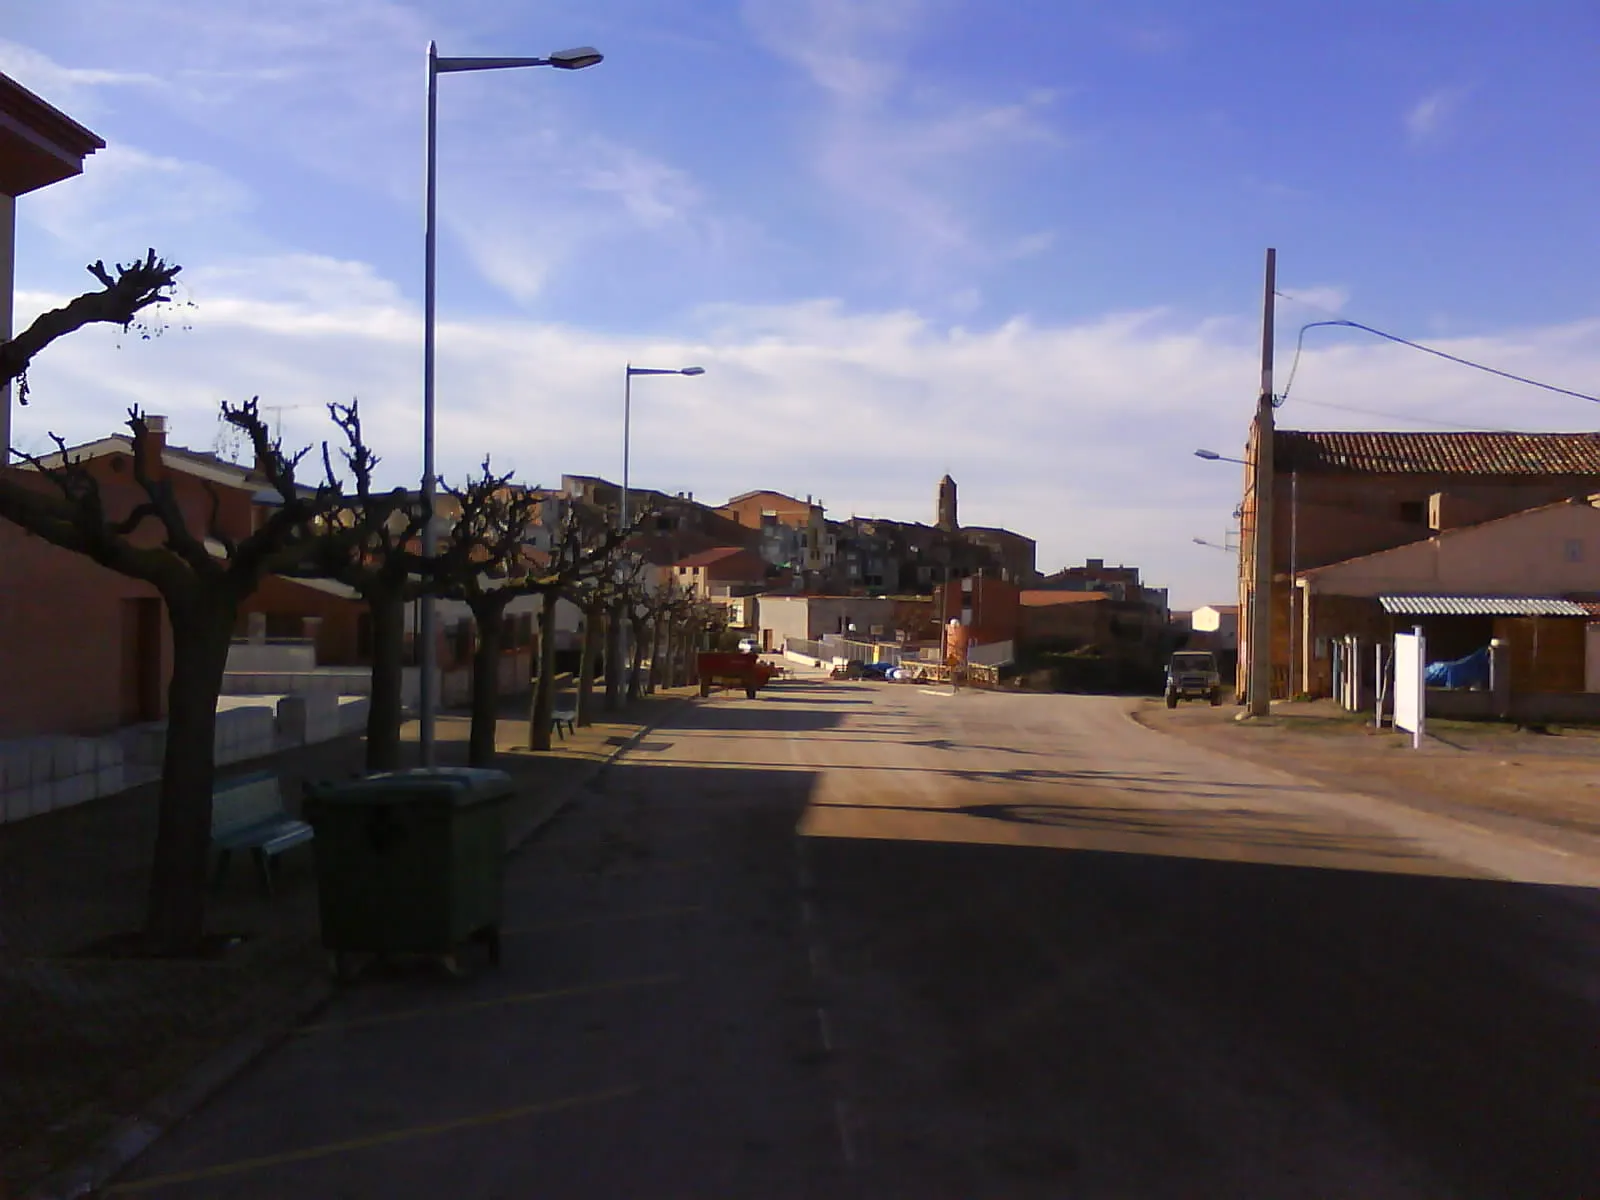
[0, 0, 1600, 605]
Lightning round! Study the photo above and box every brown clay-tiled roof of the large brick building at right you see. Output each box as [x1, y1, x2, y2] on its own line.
[1272, 429, 1600, 477]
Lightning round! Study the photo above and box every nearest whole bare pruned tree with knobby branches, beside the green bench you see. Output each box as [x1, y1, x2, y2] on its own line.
[0, 404, 339, 954]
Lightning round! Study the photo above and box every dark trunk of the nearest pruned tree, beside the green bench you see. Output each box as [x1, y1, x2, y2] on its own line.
[144, 589, 237, 955]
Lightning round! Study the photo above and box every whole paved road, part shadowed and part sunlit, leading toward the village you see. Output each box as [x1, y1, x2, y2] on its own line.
[106, 678, 1600, 1200]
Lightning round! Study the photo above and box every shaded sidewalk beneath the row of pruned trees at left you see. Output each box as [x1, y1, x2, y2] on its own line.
[0, 688, 693, 1197]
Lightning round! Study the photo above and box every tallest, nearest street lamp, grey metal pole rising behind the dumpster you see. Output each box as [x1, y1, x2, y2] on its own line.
[419, 42, 603, 766]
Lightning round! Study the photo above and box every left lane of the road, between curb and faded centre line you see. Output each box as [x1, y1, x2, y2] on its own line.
[84, 678, 862, 1200]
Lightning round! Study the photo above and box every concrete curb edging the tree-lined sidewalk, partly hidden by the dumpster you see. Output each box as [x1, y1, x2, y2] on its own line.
[22, 696, 696, 1200]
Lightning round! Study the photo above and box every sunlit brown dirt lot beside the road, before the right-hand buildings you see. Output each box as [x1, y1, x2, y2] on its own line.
[1134, 699, 1600, 856]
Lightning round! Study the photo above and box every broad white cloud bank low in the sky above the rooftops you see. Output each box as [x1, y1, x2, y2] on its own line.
[16, 256, 1600, 606]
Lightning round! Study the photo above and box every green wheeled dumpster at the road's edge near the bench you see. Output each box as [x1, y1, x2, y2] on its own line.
[304, 766, 512, 978]
